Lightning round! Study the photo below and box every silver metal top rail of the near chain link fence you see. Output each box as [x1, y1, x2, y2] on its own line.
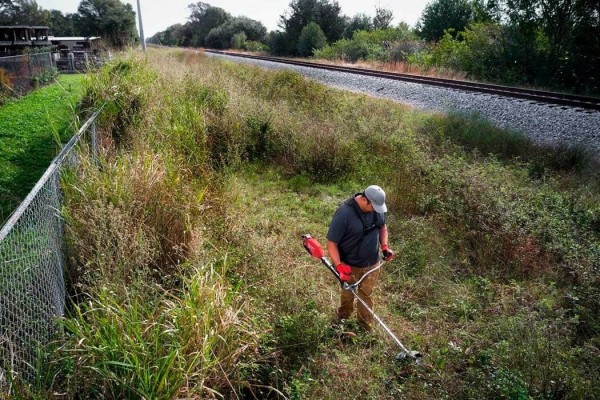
[0, 104, 104, 242]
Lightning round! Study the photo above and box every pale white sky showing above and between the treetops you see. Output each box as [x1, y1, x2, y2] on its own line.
[37, 0, 431, 38]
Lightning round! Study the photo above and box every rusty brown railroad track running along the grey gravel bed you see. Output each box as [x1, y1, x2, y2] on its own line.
[204, 49, 600, 111]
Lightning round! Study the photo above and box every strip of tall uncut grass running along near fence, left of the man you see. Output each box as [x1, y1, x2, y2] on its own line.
[11, 57, 256, 399]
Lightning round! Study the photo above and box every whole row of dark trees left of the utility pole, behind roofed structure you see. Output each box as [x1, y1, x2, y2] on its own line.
[0, 0, 139, 48]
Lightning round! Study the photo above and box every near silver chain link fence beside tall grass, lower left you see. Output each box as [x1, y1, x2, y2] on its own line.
[0, 110, 100, 386]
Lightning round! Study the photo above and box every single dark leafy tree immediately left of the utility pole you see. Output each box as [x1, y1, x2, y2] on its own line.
[75, 0, 138, 48]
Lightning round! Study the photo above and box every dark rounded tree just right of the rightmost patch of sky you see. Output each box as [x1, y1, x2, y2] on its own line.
[417, 0, 474, 41]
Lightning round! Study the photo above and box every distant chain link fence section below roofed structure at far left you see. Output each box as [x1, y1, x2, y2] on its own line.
[0, 53, 54, 93]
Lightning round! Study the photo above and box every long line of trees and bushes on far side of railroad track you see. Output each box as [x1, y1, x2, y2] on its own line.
[148, 0, 600, 95]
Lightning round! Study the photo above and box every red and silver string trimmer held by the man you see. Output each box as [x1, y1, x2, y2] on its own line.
[302, 234, 423, 366]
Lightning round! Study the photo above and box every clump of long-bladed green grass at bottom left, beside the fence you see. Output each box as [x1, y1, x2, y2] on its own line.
[54, 264, 253, 399]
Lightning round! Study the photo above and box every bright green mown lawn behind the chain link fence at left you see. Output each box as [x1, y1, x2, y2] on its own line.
[0, 75, 83, 223]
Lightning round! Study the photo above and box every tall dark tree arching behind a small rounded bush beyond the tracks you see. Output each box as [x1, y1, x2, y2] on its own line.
[279, 0, 347, 54]
